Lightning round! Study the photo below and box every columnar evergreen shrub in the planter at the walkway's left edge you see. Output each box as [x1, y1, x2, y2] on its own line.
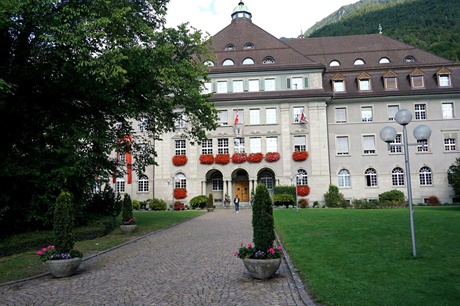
[53, 191, 75, 253]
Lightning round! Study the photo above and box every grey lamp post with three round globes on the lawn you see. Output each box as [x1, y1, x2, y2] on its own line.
[380, 109, 431, 257]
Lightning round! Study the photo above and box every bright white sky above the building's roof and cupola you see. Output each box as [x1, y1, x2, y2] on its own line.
[166, 0, 358, 38]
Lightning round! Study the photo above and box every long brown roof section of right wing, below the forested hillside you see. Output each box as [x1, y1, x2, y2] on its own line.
[284, 34, 455, 71]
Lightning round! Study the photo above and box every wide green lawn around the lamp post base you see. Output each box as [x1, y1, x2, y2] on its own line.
[274, 207, 460, 306]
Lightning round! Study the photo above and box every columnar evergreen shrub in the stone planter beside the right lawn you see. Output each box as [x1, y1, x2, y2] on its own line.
[252, 184, 275, 251]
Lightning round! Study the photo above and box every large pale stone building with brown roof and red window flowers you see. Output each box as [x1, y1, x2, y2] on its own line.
[116, 2, 460, 205]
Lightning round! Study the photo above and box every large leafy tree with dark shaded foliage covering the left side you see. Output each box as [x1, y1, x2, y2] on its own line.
[0, 0, 217, 229]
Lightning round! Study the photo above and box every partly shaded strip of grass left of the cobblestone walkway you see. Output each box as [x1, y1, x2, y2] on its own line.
[0, 211, 203, 283]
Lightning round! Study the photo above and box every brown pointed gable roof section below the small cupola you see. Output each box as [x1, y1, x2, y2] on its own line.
[210, 19, 324, 73]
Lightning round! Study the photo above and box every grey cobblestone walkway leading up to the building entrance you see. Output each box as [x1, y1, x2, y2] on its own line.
[0, 209, 314, 306]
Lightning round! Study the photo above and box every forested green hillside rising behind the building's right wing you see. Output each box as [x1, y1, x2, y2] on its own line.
[306, 0, 460, 61]
